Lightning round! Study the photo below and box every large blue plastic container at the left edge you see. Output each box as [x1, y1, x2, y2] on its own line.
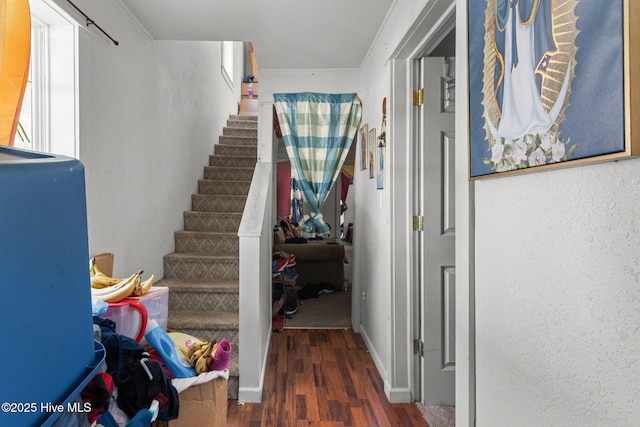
[0, 147, 104, 426]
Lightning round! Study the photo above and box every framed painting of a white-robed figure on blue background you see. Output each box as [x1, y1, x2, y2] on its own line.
[468, 0, 640, 179]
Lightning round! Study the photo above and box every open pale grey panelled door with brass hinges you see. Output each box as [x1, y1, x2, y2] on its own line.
[414, 57, 456, 406]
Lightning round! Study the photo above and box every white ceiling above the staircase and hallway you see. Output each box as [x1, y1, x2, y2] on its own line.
[120, 0, 395, 69]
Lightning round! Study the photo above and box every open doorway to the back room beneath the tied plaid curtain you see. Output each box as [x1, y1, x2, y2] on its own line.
[272, 139, 356, 329]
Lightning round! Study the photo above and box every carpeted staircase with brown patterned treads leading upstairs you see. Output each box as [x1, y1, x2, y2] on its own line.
[158, 115, 258, 400]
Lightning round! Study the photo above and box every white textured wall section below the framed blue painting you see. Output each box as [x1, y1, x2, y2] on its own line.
[476, 160, 640, 426]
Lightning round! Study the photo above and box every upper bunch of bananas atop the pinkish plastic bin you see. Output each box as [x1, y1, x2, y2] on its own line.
[89, 259, 155, 303]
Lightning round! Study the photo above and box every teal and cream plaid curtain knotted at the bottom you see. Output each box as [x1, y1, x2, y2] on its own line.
[274, 92, 362, 237]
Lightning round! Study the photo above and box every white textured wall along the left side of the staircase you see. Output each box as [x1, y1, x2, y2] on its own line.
[50, 0, 243, 277]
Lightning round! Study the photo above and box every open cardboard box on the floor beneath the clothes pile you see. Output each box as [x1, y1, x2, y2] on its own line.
[169, 378, 227, 427]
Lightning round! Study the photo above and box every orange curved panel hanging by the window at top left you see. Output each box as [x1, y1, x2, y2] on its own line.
[0, 0, 31, 146]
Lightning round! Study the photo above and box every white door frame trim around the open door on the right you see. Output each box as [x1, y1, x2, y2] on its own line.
[388, 0, 475, 426]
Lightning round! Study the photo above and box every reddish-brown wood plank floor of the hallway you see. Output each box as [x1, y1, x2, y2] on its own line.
[227, 329, 427, 427]
